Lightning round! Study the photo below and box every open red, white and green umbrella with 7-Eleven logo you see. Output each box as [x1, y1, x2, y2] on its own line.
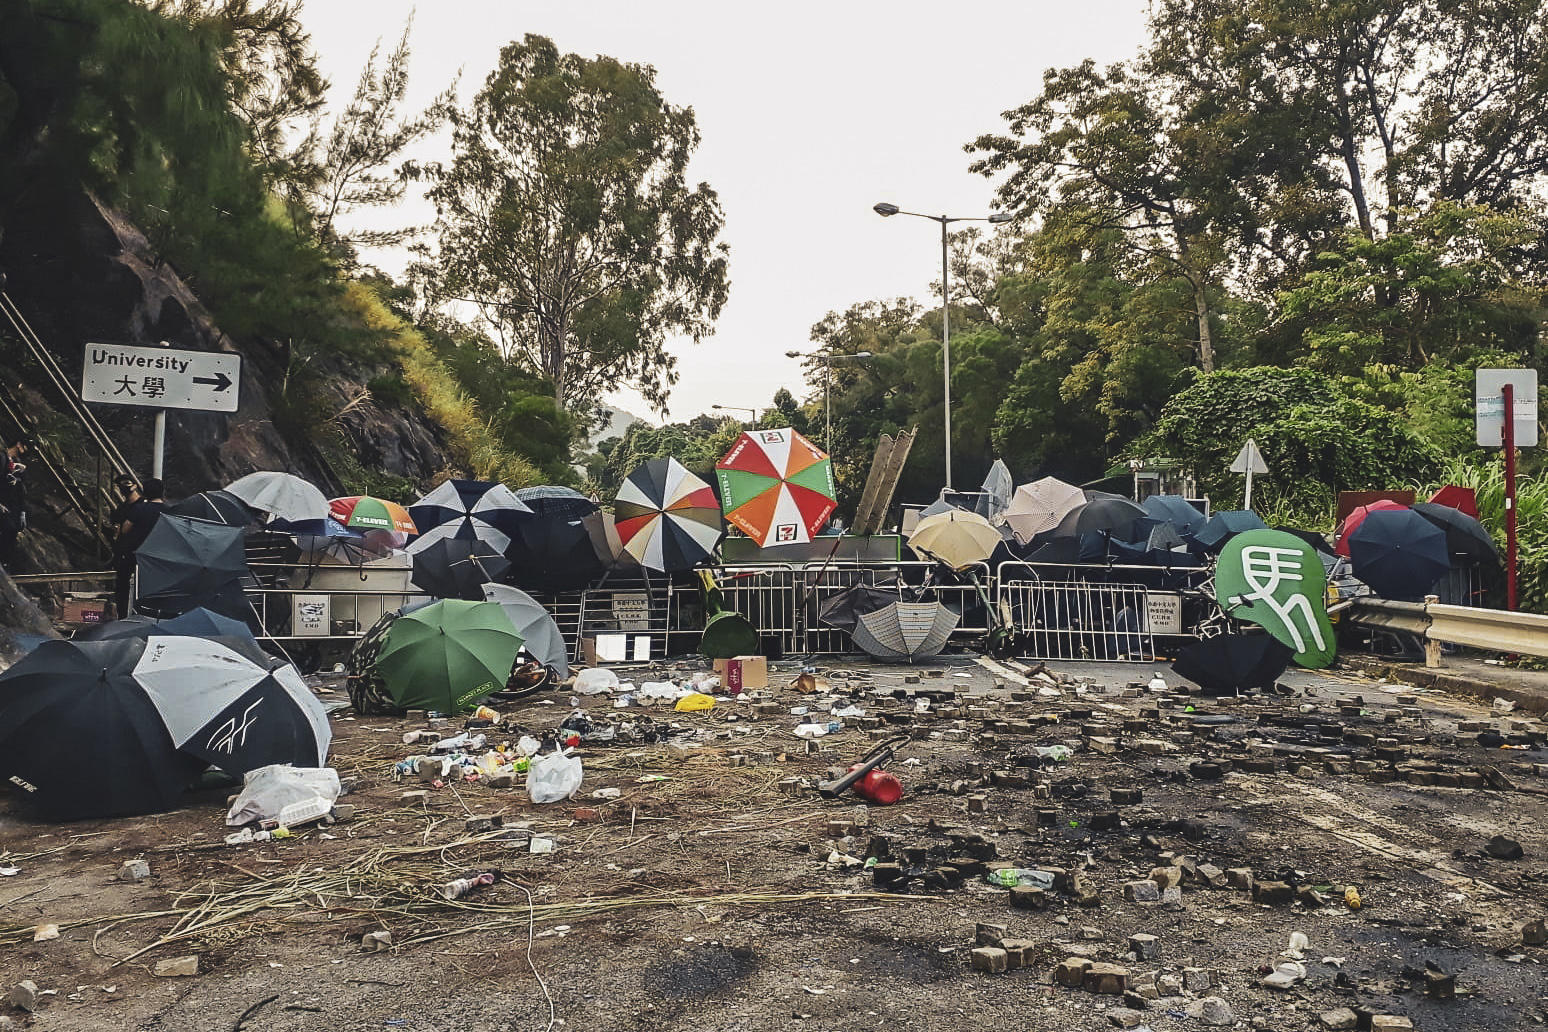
[715, 427, 837, 545]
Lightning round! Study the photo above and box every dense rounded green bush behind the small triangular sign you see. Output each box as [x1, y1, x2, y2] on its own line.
[1130, 367, 1441, 526]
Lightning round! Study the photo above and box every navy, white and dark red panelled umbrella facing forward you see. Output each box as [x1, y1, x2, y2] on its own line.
[613, 458, 721, 572]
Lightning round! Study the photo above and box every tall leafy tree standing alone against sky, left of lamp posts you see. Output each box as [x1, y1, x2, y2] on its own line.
[426, 36, 729, 412]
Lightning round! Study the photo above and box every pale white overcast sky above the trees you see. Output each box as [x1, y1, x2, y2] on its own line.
[303, 0, 1146, 419]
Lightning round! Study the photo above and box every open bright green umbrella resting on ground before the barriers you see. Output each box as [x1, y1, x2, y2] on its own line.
[376, 599, 523, 713]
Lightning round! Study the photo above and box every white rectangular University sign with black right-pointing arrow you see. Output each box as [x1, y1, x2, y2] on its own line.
[80, 343, 241, 412]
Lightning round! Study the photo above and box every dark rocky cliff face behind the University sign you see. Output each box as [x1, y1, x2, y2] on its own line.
[0, 195, 452, 571]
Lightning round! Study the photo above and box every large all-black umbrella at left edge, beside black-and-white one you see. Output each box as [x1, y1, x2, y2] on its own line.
[0, 637, 204, 820]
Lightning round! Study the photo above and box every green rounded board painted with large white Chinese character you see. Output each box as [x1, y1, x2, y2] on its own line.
[1215, 531, 1334, 670]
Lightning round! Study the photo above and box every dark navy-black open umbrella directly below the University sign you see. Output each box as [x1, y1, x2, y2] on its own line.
[135, 514, 249, 616]
